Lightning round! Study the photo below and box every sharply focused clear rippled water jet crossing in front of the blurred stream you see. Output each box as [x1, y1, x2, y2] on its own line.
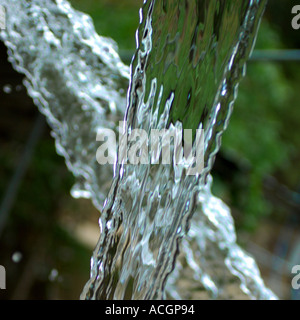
[82, 0, 272, 299]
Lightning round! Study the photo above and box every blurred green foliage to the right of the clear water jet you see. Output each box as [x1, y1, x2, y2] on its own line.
[218, 19, 300, 229]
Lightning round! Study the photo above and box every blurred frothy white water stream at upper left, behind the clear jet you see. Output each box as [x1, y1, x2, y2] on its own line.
[0, 0, 129, 210]
